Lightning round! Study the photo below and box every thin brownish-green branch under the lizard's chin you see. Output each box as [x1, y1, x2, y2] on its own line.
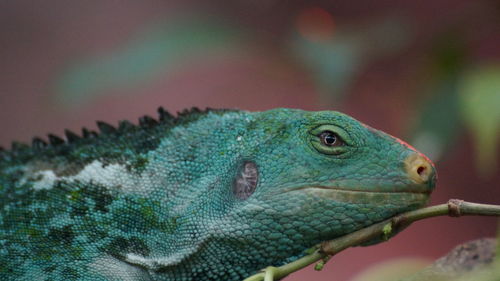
[244, 199, 500, 281]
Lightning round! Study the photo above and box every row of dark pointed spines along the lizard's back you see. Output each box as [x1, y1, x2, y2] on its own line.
[0, 107, 232, 158]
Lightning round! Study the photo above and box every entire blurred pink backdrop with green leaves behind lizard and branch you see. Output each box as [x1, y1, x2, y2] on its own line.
[0, 0, 500, 281]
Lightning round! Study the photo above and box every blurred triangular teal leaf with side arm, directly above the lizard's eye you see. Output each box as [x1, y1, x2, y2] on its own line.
[290, 17, 412, 104]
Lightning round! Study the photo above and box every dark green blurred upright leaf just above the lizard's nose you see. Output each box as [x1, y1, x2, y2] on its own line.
[411, 30, 467, 161]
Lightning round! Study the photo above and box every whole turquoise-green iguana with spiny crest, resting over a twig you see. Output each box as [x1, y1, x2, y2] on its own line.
[0, 108, 436, 281]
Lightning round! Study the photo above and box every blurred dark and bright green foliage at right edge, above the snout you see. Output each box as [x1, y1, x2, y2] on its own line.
[412, 32, 500, 177]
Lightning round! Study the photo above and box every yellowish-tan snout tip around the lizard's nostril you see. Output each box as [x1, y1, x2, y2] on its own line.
[404, 152, 436, 188]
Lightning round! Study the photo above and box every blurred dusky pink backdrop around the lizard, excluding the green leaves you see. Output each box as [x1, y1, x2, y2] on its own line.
[0, 0, 500, 281]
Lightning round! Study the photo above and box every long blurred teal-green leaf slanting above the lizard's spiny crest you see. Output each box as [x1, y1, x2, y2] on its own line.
[56, 16, 241, 107]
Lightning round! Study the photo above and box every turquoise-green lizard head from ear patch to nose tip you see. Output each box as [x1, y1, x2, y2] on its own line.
[229, 109, 436, 245]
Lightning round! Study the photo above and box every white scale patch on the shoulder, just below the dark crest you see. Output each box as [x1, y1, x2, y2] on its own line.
[25, 160, 154, 192]
